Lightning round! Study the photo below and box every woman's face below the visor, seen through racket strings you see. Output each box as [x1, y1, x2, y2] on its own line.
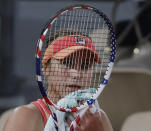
[45, 52, 94, 103]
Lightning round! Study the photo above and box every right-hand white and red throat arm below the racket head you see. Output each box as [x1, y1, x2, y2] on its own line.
[69, 107, 89, 131]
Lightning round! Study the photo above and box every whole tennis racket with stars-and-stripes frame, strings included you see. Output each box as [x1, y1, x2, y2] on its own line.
[36, 5, 116, 131]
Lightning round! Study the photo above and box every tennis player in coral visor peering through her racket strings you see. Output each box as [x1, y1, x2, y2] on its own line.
[3, 35, 113, 131]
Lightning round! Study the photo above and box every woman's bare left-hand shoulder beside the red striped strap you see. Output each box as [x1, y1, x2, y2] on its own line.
[4, 104, 43, 131]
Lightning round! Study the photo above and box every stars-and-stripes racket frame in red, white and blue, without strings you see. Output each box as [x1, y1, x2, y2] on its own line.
[35, 5, 116, 131]
